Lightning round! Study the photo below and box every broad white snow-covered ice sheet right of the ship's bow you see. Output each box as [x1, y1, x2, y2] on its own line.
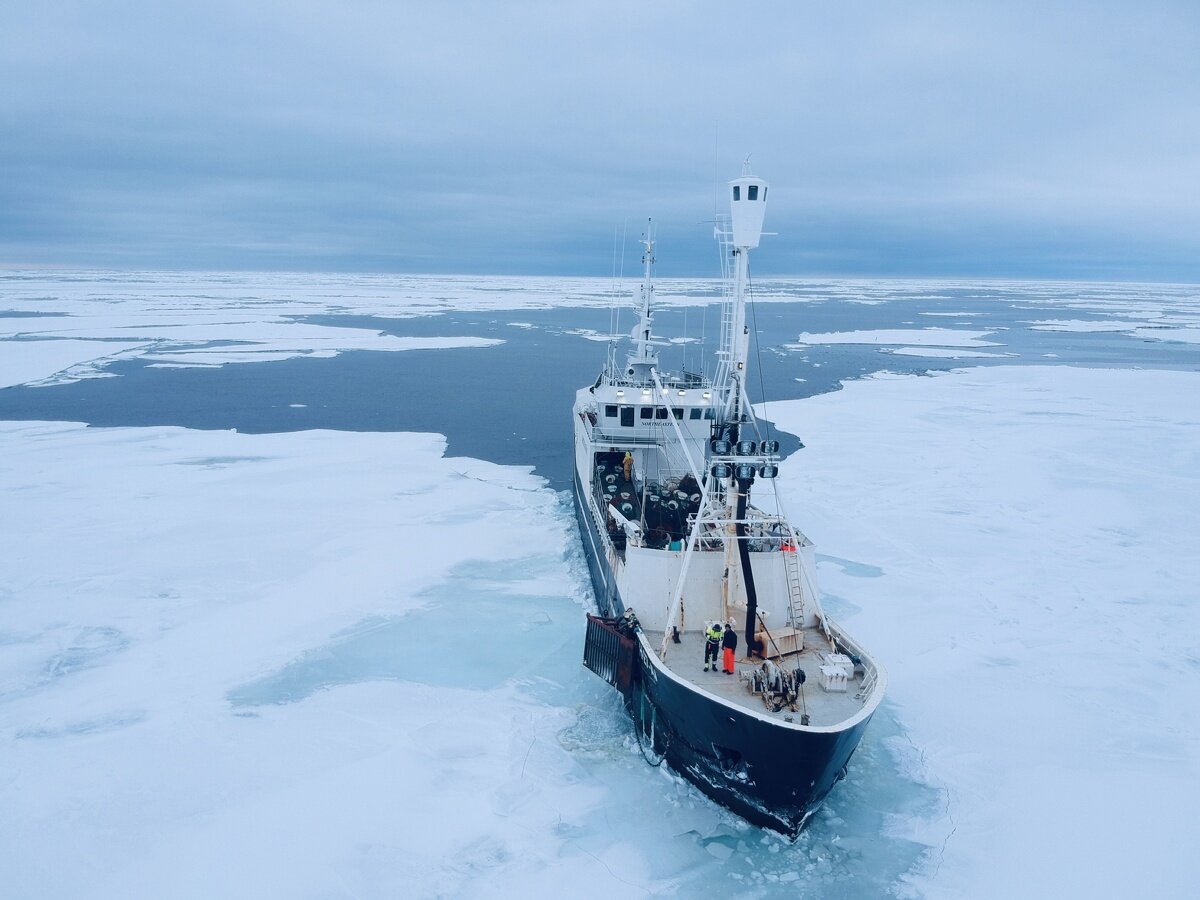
[768, 366, 1200, 898]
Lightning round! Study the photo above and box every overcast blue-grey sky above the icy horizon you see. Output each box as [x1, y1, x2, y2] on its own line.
[0, 0, 1200, 282]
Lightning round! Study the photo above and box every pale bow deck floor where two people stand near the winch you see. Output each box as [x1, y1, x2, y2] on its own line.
[644, 628, 866, 726]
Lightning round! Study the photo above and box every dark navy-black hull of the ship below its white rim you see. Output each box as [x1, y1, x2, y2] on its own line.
[575, 474, 871, 838]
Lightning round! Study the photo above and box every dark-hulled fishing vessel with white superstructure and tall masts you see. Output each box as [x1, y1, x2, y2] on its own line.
[574, 168, 886, 838]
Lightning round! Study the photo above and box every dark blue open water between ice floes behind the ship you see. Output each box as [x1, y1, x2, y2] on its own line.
[0, 290, 1200, 488]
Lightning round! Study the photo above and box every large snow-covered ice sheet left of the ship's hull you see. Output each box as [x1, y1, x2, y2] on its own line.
[0, 422, 613, 896]
